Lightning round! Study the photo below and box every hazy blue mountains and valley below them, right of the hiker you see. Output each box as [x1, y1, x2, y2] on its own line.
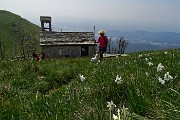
[107, 30, 180, 52]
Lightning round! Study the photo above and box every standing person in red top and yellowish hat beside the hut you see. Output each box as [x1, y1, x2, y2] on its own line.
[97, 30, 108, 61]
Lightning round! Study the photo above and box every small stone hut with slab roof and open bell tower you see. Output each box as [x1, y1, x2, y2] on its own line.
[40, 16, 96, 58]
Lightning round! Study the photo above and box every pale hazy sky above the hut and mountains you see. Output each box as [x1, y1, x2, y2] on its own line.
[0, 0, 180, 32]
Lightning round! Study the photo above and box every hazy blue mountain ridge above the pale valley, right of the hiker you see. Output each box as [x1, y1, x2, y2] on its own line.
[107, 30, 180, 44]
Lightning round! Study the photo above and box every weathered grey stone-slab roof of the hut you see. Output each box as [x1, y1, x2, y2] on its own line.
[40, 31, 95, 45]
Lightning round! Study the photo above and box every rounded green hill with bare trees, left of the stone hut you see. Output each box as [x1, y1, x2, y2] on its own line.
[0, 10, 40, 58]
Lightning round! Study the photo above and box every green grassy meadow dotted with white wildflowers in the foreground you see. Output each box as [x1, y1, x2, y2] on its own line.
[0, 49, 180, 120]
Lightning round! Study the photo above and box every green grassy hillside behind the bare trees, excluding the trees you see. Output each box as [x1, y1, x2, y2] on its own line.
[0, 10, 40, 57]
